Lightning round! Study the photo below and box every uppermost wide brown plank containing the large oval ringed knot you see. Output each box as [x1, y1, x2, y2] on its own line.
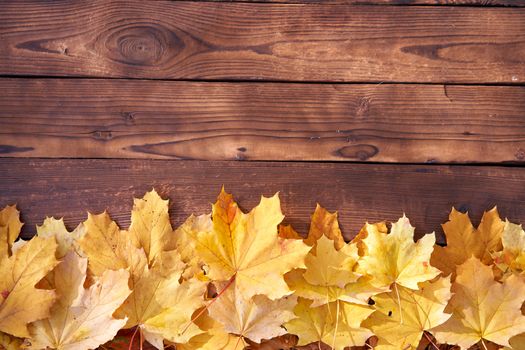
[0, 0, 525, 84]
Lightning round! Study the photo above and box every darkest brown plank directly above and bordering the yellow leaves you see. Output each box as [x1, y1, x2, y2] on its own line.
[0, 158, 525, 241]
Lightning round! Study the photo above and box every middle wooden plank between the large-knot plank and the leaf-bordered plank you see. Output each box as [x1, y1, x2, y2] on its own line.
[0, 79, 525, 163]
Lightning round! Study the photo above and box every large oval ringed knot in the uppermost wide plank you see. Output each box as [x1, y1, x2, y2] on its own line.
[105, 25, 179, 66]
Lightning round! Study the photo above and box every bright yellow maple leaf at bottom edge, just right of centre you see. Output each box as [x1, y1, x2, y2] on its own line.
[285, 298, 374, 350]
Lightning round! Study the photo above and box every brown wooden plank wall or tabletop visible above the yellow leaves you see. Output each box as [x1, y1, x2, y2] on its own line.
[0, 0, 525, 243]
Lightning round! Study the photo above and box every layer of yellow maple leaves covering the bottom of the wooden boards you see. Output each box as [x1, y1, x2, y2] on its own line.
[0, 191, 525, 350]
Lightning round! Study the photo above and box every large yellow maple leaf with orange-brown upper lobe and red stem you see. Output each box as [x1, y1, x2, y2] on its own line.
[186, 190, 310, 299]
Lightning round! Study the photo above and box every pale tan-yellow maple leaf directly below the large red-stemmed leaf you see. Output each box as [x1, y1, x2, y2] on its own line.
[208, 284, 297, 343]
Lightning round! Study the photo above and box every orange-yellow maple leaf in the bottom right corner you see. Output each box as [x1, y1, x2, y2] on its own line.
[434, 257, 525, 349]
